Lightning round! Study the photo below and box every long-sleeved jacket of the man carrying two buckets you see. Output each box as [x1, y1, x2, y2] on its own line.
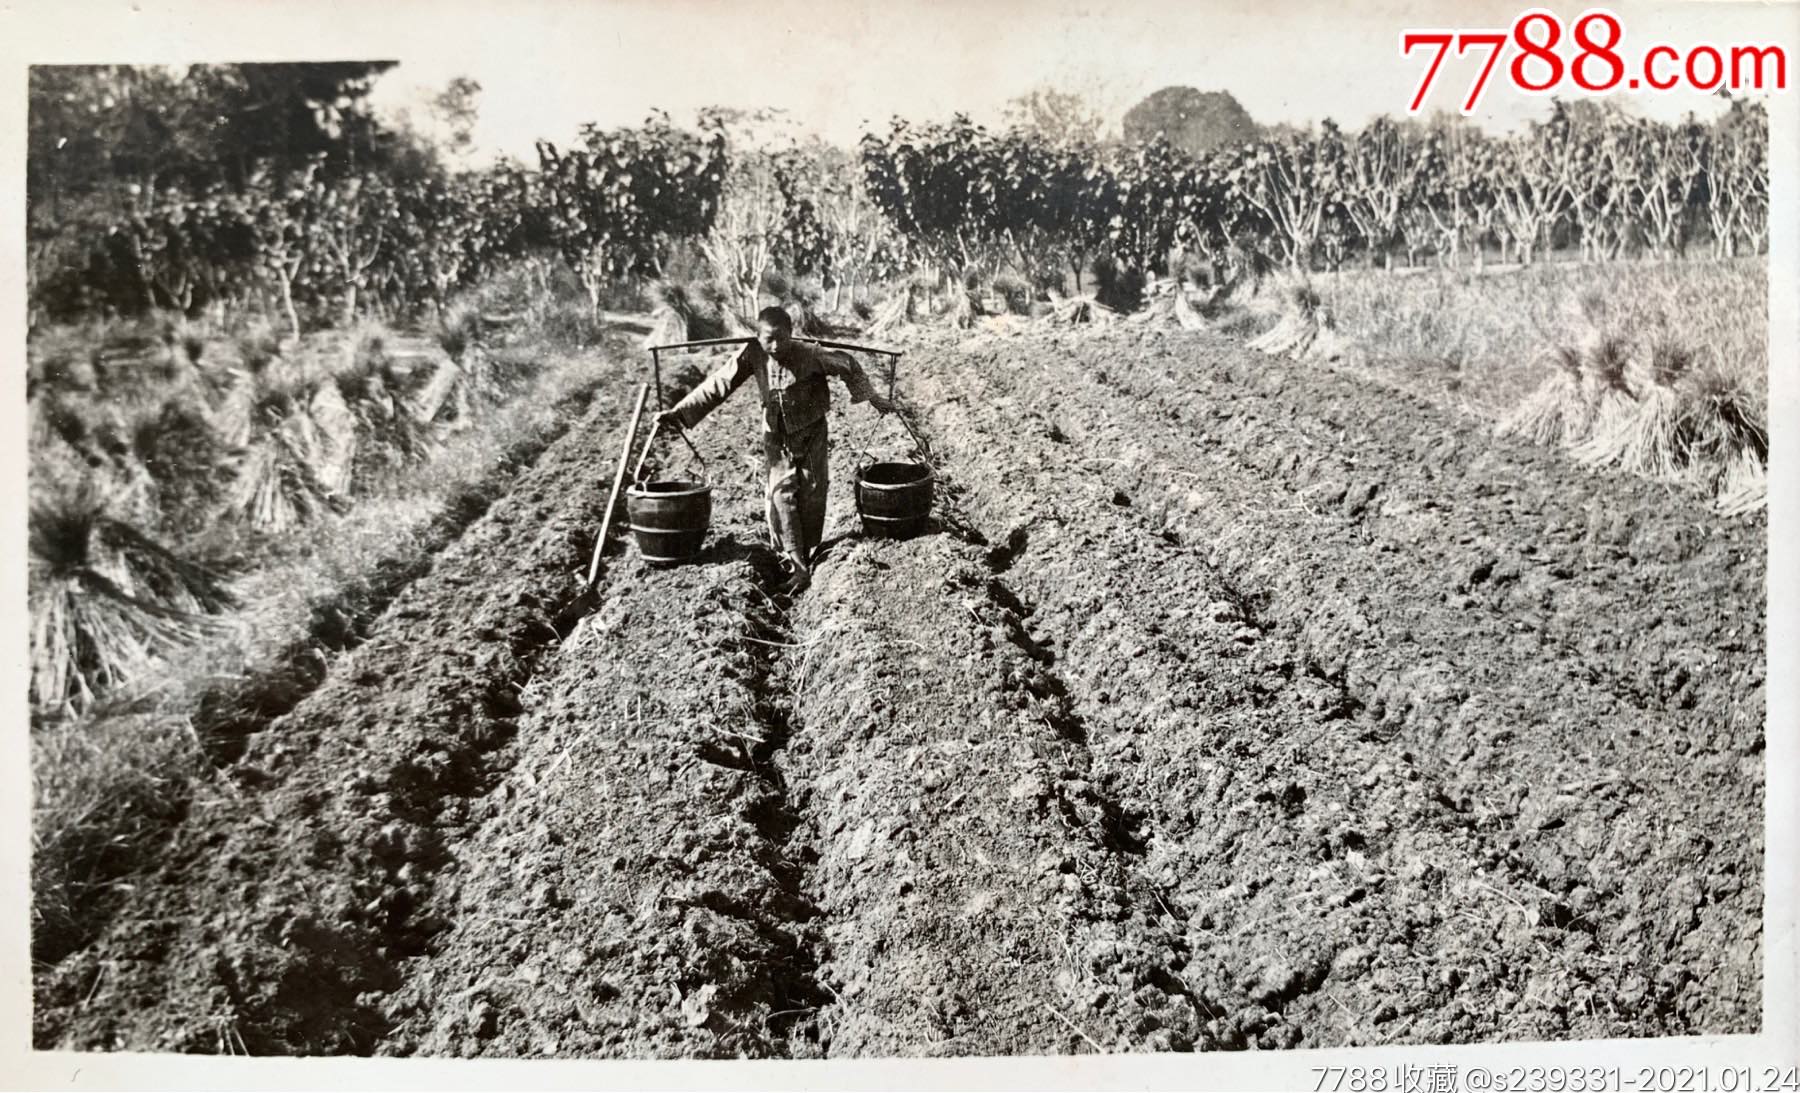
[675, 342, 875, 438]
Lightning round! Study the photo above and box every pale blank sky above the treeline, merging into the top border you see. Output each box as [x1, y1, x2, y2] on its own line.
[343, 0, 1800, 162]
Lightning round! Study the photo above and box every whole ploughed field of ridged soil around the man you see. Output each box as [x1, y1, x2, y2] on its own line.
[38, 333, 1764, 1057]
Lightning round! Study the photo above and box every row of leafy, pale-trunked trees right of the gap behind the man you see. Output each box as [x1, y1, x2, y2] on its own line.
[862, 103, 1769, 297]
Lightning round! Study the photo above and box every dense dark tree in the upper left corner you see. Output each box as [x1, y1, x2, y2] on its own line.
[25, 61, 417, 317]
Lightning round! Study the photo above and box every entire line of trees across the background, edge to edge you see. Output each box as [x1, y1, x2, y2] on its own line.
[29, 65, 1768, 331]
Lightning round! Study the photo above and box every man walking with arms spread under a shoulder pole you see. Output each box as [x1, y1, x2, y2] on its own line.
[657, 308, 895, 592]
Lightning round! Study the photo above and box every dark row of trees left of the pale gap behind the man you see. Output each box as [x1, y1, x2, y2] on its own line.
[27, 65, 725, 333]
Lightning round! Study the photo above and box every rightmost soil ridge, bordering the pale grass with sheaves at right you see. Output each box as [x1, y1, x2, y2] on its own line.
[1085, 335, 1764, 724]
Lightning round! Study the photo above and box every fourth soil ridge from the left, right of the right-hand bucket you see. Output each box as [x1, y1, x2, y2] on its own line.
[914, 345, 1533, 1048]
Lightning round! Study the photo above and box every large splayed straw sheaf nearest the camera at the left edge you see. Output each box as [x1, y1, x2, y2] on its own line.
[29, 488, 236, 713]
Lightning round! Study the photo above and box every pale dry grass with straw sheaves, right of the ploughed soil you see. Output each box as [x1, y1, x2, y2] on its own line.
[1210, 257, 1768, 513]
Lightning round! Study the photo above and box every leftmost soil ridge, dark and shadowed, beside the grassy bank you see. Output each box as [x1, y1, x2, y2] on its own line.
[34, 360, 648, 1053]
